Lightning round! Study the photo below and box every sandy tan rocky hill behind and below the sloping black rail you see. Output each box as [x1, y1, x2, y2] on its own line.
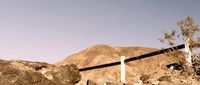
[57, 45, 198, 85]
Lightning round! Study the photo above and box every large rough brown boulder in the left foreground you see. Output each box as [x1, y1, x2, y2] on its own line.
[0, 60, 81, 85]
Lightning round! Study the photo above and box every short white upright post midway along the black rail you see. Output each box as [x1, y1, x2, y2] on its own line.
[121, 56, 126, 84]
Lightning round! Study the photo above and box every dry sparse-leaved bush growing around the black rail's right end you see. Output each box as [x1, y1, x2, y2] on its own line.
[159, 16, 200, 75]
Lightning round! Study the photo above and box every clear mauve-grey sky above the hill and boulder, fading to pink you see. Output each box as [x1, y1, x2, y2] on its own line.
[0, 0, 200, 63]
